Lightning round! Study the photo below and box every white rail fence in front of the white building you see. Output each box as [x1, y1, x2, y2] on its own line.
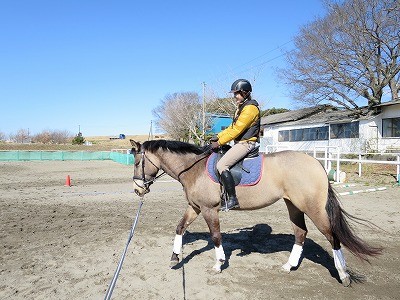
[265, 145, 400, 182]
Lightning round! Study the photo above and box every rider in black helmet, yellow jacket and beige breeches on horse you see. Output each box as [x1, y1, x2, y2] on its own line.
[211, 79, 260, 211]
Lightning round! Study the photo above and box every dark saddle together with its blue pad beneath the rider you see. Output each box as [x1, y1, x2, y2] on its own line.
[206, 146, 264, 186]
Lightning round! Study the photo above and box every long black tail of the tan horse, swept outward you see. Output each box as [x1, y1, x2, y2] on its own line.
[325, 184, 382, 262]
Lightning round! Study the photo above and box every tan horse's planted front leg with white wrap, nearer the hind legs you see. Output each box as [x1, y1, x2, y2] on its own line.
[201, 208, 225, 273]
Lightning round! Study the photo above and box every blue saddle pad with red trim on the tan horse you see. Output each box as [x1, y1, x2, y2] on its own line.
[206, 153, 264, 186]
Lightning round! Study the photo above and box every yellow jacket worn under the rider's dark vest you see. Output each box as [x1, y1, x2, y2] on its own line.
[218, 105, 260, 145]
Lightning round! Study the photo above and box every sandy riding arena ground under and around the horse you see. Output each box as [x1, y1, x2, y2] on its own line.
[0, 161, 400, 300]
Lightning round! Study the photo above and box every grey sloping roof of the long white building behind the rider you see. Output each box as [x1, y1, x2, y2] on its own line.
[261, 105, 369, 127]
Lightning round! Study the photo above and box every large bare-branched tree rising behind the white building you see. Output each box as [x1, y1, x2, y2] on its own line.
[280, 0, 400, 110]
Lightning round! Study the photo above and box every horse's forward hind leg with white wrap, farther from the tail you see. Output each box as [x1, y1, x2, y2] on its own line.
[282, 199, 307, 272]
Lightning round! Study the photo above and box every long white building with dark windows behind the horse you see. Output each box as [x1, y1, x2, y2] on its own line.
[260, 100, 400, 153]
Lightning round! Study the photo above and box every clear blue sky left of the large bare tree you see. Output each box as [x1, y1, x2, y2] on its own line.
[0, 0, 323, 136]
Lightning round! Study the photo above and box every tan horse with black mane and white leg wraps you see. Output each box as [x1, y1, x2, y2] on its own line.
[130, 140, 382, 286]
